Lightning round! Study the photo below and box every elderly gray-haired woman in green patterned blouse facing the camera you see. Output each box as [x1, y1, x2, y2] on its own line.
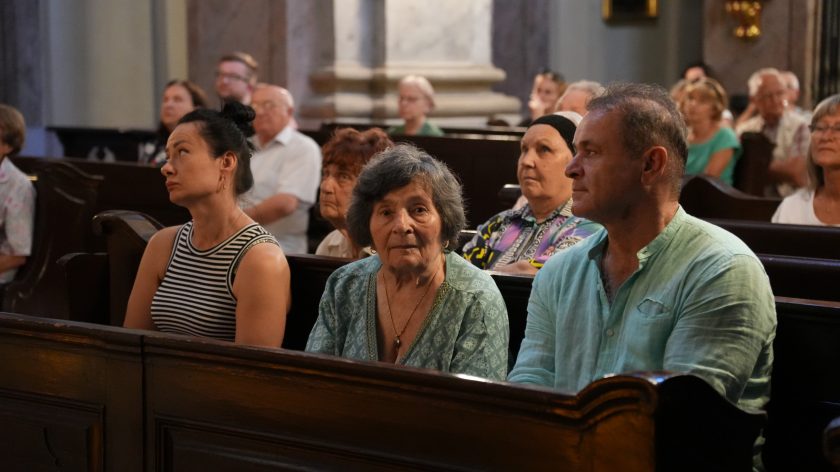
[306, 145, 509, 380]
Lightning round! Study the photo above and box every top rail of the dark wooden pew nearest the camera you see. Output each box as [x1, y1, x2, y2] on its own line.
[0, 312, 736, 422]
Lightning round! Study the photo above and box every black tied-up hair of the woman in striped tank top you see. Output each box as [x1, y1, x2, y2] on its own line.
[178, 102, 256, 195]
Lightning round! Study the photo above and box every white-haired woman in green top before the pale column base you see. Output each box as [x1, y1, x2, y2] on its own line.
[388, 75, 443, 136]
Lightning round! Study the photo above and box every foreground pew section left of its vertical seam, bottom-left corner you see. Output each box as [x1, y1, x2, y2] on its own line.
[0, 314, 143, 472]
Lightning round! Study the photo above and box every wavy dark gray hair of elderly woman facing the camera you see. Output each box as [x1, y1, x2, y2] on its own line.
[347, 144, 466, 248]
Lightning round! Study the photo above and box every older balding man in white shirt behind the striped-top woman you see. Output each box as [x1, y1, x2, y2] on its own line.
[240, 84, 321, 254]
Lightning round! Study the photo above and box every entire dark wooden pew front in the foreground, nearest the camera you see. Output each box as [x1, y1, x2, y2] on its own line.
[0, 314, 764, 471]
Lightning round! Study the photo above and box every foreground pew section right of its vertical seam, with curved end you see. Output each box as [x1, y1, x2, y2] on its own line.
[144, 335, 762, 471]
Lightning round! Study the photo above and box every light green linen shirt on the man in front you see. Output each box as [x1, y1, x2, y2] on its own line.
[508, 207, 776, 409]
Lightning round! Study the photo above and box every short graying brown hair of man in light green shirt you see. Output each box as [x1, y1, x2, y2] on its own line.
[587, 83, 688, 195]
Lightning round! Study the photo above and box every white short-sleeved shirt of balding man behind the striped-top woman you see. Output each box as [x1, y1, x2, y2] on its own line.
[239, 126, 321, 254]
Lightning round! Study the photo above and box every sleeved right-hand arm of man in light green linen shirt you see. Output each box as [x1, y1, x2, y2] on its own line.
[663, 254, 776, 403]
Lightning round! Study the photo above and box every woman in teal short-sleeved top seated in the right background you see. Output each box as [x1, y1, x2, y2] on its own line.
[680, 77, 741, 185]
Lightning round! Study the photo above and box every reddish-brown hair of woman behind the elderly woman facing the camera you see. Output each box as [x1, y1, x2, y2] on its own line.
[323, 128, 394, 175]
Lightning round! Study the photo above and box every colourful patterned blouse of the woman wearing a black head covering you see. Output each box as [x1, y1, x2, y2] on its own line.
[462, 199, 601, 270]
